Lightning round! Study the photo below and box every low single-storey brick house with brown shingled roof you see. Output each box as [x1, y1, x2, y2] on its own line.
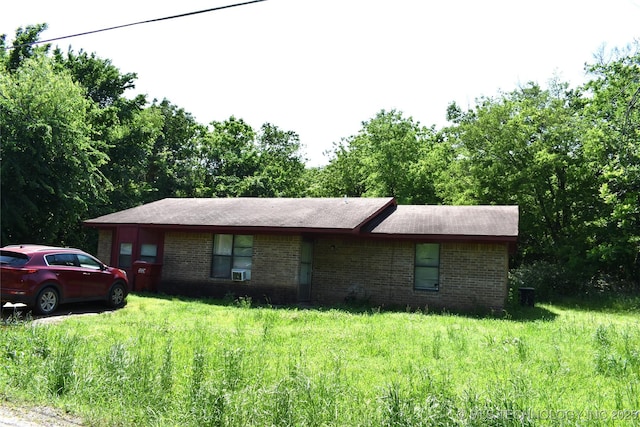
[85, 198, 518, 310]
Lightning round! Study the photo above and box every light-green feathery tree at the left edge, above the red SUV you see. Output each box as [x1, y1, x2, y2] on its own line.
[0, 55, 109, 244]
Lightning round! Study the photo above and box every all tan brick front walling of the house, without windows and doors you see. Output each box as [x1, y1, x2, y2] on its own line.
[130, 232, 508, 310]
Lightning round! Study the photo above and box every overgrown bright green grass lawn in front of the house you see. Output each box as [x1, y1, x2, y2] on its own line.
[0, 295, 640, 426]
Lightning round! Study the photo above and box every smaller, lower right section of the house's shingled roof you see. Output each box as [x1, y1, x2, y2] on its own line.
[371, 205, 518, 237]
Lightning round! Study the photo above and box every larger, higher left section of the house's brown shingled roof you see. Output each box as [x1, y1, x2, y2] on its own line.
[85, 197, 395, 231]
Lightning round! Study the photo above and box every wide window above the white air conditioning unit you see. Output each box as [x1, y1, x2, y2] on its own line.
[211, 234, 253, 280]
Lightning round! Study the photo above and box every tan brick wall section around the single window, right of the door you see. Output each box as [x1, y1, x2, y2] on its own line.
[312, 238, 508, 310]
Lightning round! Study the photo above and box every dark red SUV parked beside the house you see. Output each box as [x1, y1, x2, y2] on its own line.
[0, 245, 129, 314]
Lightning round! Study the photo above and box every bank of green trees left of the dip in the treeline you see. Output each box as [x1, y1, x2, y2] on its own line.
[0, 24, 305, 246]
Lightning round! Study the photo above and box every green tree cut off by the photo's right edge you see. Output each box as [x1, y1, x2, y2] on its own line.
[585, 41, 640, 287]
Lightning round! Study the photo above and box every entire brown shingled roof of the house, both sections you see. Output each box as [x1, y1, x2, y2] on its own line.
[85, 197, 518, 241]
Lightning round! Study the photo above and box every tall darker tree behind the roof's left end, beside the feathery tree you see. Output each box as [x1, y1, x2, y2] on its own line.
[53, 49, 152, 216]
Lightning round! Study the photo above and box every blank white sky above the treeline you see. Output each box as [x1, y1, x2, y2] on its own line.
[0, 0, 640, 166]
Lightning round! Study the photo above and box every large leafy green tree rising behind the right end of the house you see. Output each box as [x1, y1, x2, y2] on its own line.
[448, 81, 598, 271]
